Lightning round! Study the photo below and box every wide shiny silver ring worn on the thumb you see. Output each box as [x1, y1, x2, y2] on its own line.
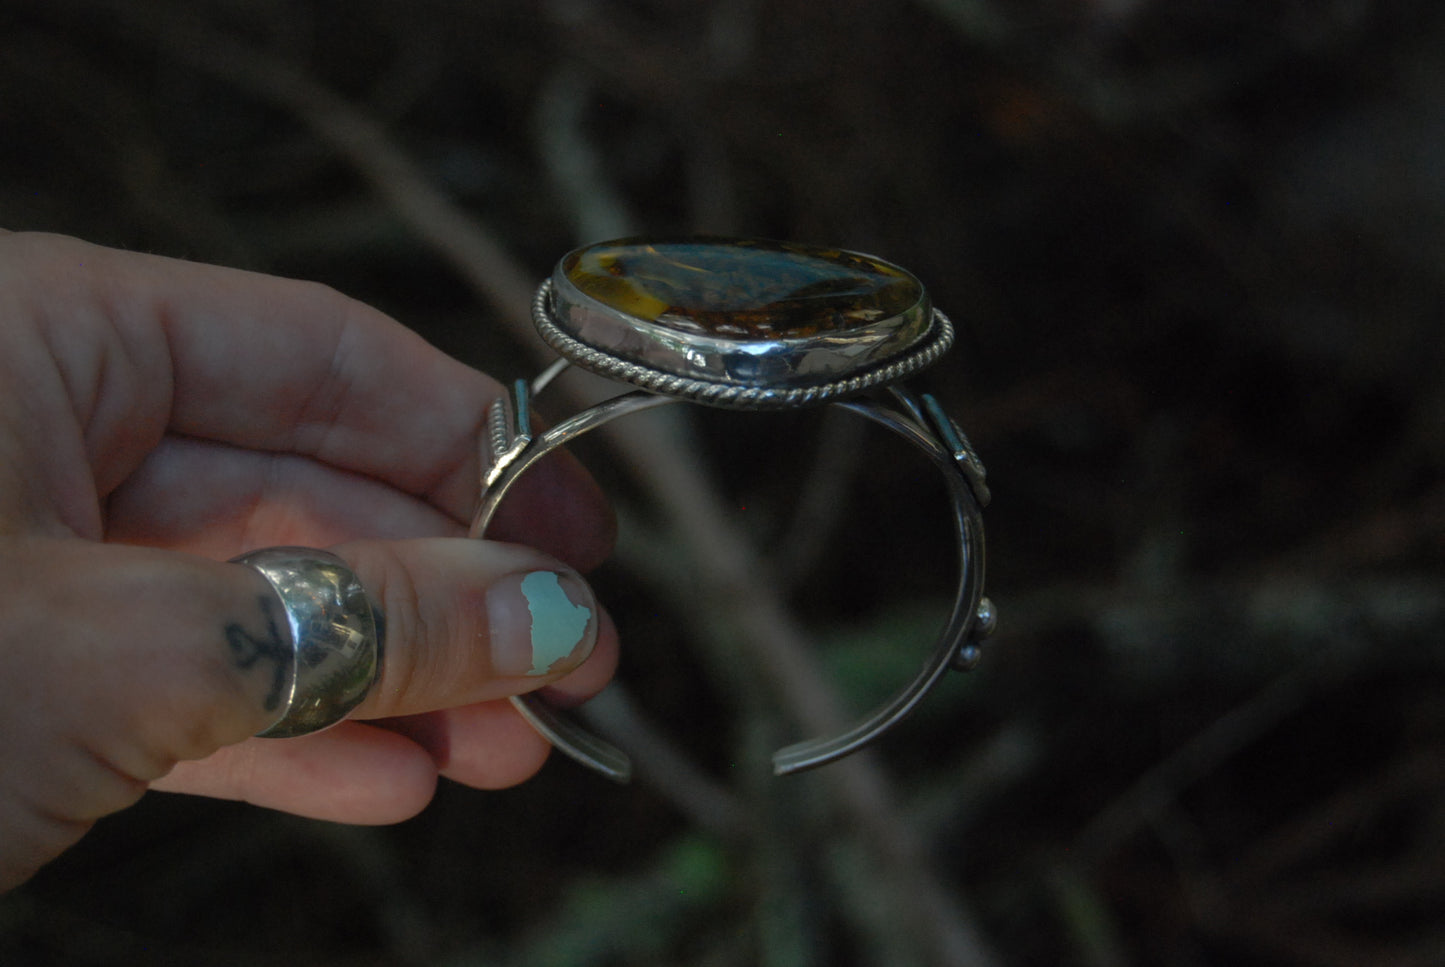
[233, 548, 381, 739]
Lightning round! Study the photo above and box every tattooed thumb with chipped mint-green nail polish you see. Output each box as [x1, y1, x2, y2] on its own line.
[0, 536, 614, 889]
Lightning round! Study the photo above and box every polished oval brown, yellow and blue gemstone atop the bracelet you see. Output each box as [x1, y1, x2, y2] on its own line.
[561, 238, 923, 340]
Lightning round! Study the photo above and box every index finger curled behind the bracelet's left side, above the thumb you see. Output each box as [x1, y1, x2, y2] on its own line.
[4, 234, 611, 562]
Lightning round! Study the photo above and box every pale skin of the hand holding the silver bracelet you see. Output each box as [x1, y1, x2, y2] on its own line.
[0, 231, 617, 890]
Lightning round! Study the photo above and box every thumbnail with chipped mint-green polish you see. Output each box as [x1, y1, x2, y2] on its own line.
[487, 571, 597, 675]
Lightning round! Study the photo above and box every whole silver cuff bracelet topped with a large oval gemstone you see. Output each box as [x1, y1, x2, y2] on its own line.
[471, 238, 997, 782]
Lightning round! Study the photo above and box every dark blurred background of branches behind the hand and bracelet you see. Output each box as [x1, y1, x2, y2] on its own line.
[0, 0, 1445, 967]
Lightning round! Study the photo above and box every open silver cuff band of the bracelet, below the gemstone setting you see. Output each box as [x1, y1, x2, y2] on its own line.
[471, 358, 997, 782]
